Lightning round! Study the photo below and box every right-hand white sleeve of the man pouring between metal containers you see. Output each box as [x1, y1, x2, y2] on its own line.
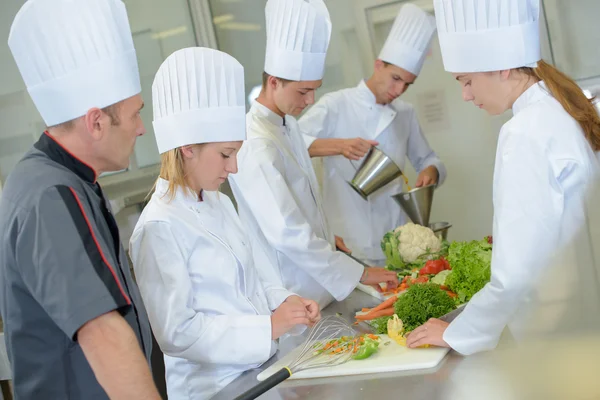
[407, 109, 447, 186]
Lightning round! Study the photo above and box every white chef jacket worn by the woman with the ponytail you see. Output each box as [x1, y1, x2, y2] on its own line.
[444, 83, 599, 354]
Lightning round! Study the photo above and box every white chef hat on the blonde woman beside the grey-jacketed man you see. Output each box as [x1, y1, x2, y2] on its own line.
[152, 47, 246, 154]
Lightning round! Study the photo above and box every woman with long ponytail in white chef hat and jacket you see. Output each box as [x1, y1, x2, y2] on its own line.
[407, 0, 600, 354]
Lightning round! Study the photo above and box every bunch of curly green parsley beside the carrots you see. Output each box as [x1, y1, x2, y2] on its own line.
[394, 283, 456, 332]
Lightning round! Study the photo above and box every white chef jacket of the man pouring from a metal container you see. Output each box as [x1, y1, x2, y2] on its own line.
[298, 81, 446, 265]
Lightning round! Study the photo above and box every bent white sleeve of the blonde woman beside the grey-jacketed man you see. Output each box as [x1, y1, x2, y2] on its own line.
[131, 222, 273, 365]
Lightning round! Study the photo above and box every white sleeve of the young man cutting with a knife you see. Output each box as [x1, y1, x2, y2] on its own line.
[233, 139, 364, 301]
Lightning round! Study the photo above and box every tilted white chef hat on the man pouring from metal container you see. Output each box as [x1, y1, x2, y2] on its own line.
[379, 3, 436, 75]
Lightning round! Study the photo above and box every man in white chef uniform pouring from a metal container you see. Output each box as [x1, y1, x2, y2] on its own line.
[298, 4, 446, 265]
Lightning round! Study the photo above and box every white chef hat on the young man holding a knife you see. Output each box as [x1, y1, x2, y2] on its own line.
[265, 0, 331, 81]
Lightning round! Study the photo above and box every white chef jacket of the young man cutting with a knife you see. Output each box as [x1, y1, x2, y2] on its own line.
[230, 102, 364, 308]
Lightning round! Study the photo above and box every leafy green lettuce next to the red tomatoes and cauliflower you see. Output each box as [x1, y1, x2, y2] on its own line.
[445, 239, 492, 303]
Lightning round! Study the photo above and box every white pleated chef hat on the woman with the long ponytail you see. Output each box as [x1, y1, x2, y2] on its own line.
[434, 0, 541, 73]
